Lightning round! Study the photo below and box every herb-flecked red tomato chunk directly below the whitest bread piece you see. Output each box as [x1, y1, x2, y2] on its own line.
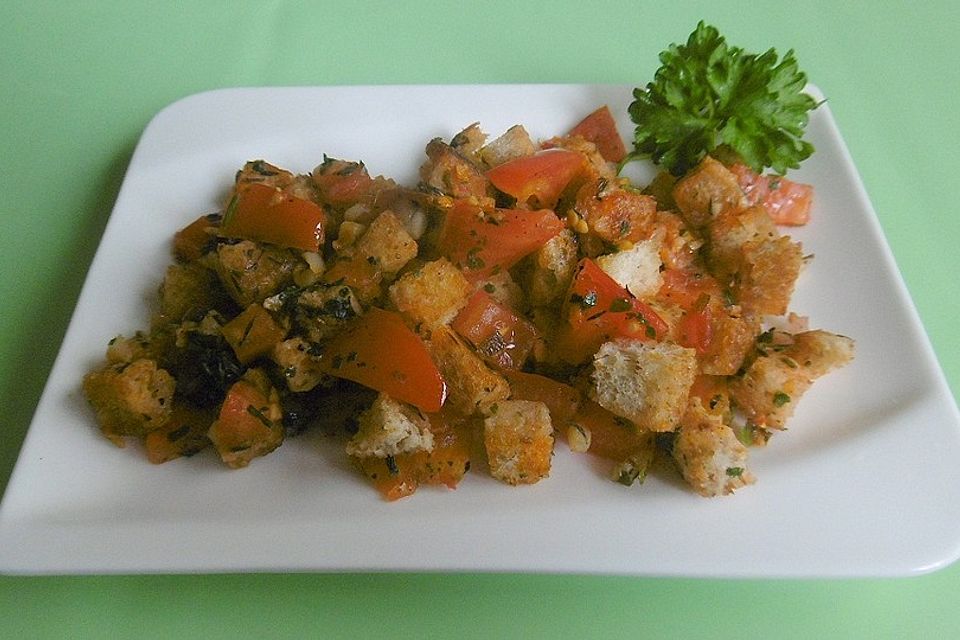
[556, 258, 668, 364]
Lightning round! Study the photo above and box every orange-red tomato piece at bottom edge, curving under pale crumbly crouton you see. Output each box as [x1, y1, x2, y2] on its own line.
[354, 412, 470, 501]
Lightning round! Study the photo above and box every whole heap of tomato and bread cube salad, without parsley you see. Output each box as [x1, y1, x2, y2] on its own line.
[84, 106, 853, 500]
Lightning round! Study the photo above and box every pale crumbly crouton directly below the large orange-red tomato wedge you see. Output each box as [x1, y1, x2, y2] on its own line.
[347, 393, 433, 458]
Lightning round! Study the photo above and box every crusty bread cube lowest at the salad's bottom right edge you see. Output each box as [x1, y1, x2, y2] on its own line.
[672, 398, 754, 497]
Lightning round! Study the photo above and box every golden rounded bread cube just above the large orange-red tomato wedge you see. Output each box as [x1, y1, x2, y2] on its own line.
[390, 258, 473, 331]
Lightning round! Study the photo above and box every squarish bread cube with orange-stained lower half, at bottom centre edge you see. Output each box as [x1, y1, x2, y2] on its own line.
[483, 400, 553, 485]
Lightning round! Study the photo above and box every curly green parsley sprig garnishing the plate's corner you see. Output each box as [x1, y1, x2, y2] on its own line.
[629, 22, 818, 175]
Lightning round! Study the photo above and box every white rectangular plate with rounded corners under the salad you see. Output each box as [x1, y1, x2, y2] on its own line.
[0, 85, 960, 576]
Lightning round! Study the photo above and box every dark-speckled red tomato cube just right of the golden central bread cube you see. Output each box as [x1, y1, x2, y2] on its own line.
[451, 289, 539, 369]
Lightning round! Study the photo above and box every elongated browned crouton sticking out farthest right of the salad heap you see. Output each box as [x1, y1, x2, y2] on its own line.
[730, 330, 854, 429]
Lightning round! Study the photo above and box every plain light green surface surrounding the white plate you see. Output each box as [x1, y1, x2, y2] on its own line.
[0, 0, 960, 639]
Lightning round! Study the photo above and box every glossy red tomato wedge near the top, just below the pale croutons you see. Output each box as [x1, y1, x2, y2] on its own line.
[487, 149, 587, 209]
